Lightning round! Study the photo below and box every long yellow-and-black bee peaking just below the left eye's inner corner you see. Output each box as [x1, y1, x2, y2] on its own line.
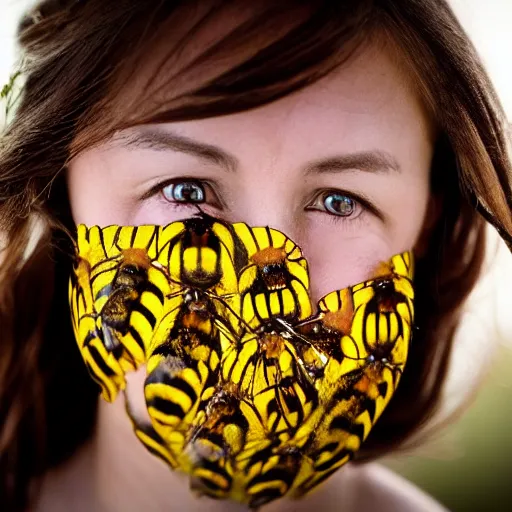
[144, 214, 252, 460]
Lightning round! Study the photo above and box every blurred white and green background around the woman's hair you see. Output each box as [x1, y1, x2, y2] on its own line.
[0, 0, 512, 512]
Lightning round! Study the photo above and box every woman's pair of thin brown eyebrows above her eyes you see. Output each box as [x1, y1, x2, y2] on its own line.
[114, 127, 401, 175]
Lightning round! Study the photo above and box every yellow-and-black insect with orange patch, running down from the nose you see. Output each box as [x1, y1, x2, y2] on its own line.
[221, 223, 322, 439]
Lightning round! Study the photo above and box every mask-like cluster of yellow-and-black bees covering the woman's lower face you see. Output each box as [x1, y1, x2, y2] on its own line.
[69, 214, 413, 508]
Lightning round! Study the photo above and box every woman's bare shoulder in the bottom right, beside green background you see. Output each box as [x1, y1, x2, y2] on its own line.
[353, 464, 447, 512]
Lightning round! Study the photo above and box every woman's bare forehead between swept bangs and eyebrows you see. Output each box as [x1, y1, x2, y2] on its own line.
[118, 42, 434, 165]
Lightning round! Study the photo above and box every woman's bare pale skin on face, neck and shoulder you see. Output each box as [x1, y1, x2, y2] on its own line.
[44, 36, 441, 512]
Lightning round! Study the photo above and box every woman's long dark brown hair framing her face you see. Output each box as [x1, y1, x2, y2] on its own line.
[0, 0, 512, 510]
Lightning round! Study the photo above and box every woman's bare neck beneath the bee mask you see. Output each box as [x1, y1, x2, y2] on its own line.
[36, 380, 357, 512]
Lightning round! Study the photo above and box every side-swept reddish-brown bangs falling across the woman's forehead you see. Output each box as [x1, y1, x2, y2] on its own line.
[72, 1, 376, 152]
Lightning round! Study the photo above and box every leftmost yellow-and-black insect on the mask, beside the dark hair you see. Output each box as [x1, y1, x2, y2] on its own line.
[69, 225, 170, 401]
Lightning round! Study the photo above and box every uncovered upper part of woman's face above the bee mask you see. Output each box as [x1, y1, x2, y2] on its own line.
[68, 46, 434, 299]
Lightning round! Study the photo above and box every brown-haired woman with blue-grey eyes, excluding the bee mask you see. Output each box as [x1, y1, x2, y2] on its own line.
[0, 0, 512, 511]
